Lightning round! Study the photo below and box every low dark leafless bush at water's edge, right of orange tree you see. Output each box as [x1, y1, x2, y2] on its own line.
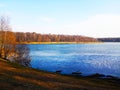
[15, 44, 31, 67]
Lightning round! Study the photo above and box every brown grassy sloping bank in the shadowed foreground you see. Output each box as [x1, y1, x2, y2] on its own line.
[0, 59, 120, 90]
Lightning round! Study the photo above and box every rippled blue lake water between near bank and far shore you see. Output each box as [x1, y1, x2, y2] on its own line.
[29, 43, 120, 77]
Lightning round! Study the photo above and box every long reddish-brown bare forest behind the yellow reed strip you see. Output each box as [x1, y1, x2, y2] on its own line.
[14, 32, 97, 42]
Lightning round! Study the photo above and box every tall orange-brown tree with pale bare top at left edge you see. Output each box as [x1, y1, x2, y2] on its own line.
[0, 16, 16, 59]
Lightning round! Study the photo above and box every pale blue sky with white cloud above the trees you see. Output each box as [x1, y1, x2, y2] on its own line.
[0, 0, 120, 37]
